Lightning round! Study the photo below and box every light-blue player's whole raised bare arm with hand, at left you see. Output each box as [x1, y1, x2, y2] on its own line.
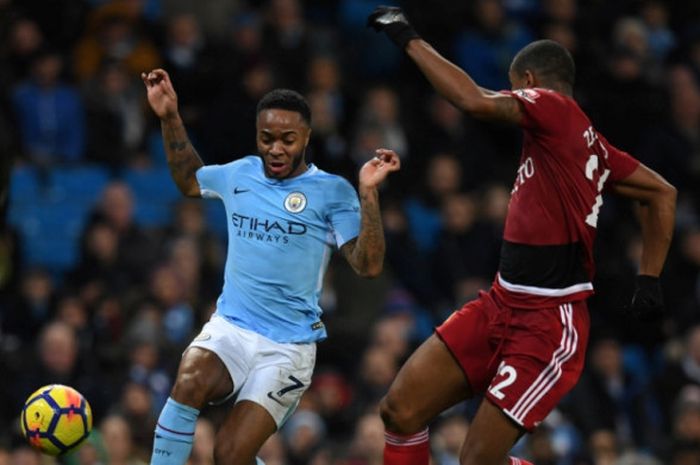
[141, 69, 204, 197]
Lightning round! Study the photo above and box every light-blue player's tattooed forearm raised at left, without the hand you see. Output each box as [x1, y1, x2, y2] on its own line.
[160, 116, 204, 197]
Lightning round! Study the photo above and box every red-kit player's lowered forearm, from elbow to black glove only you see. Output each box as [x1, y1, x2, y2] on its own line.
[639, 188, 676, 276]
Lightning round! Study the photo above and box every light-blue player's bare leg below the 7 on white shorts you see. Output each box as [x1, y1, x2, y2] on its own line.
[214, 400, 277, 465]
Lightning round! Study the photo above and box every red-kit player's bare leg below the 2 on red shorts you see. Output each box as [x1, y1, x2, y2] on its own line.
[460, 400, 524, 465]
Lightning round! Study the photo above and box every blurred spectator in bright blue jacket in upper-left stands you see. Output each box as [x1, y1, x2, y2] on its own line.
[12, 50, 85, 166]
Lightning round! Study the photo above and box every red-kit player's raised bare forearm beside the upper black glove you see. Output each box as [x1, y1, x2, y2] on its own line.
[406, 40, 485, 115]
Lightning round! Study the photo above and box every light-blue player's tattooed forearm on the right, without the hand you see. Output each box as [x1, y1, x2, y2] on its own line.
[352, 186, 386, 278]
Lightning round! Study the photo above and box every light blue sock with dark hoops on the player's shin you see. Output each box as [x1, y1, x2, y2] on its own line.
[151, 397, 199, 465]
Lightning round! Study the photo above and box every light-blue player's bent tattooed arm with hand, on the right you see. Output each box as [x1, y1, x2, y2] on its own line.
[341, 149, 401, 278]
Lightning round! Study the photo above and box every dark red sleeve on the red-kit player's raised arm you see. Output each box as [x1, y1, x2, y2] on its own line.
[501, 89, 566, 132]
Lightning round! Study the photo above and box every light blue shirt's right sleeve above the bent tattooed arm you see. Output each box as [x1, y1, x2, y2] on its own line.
[327, 179, 360, 248]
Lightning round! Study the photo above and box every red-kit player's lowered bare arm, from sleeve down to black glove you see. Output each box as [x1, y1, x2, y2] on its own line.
[612, 164, 676, 277]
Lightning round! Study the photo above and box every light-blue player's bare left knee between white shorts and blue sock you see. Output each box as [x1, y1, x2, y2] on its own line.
[171, 347, 233, 409]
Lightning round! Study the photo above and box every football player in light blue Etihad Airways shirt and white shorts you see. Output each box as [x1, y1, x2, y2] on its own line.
[142, 69, 400, 465]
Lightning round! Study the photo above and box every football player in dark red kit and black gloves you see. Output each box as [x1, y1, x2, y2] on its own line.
[368, 7, 676, 465]
